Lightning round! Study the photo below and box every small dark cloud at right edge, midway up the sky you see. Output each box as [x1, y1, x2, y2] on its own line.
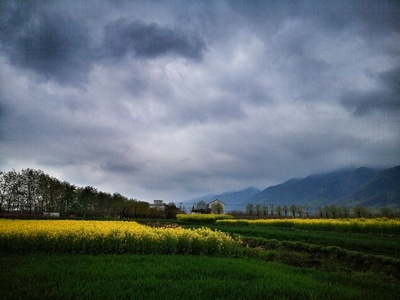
[341, 67, 400, 116]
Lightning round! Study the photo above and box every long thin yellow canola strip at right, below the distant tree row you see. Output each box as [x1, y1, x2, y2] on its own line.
[216, 218, 400, 234]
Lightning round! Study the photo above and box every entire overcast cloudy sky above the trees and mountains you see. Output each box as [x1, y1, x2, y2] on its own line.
[0, 0, 400, 202]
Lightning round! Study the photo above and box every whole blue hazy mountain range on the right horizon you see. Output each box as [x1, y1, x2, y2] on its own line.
[184, 166, 400, 211]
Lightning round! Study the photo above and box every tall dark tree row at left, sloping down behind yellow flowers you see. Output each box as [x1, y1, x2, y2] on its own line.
[0, 169, 180, 218]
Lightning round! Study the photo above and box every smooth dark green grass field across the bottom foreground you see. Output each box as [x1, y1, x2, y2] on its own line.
[0, 254, 400, 299]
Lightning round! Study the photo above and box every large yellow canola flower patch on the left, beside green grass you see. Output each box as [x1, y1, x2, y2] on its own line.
[0, 219, 241, 255]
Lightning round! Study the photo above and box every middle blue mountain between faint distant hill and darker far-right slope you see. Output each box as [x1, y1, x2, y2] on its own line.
[246, 168, 379, 206]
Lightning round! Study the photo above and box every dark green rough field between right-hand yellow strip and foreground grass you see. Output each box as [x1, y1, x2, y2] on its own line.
[181, 225, 400, 284]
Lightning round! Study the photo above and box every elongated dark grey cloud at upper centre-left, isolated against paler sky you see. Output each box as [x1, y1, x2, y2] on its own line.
[104, 19, 205, 60]
